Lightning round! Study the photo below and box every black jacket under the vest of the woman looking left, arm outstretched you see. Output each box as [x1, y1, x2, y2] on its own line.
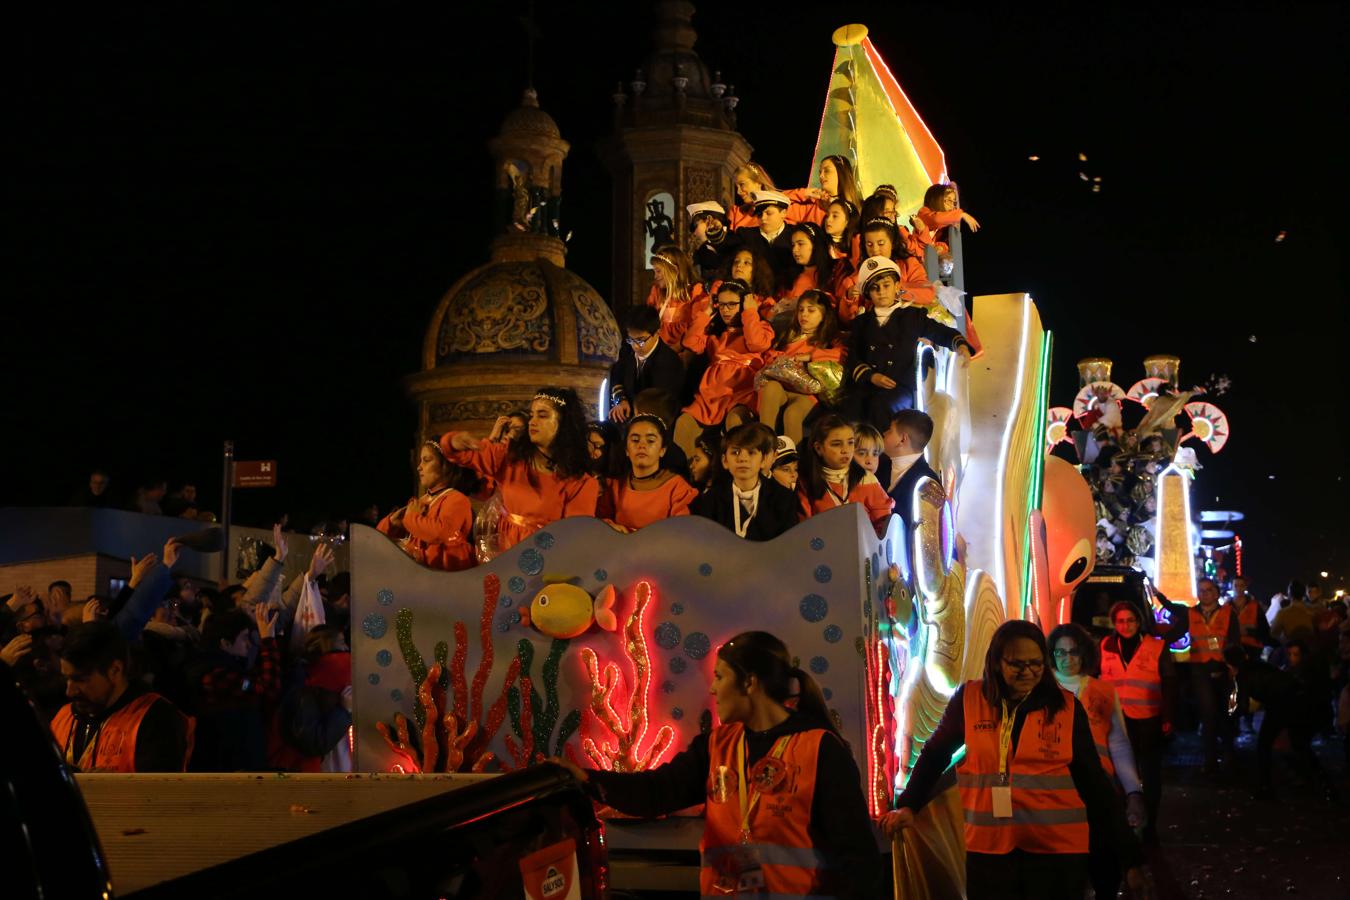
[587, 712, 884, 897]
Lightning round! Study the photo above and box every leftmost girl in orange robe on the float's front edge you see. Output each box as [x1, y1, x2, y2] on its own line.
[375, 441, 477, 572]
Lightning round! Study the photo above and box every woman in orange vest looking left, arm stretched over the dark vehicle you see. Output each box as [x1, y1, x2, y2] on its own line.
[554, 631, 883, 900]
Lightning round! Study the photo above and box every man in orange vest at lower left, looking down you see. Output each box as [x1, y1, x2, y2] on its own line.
[51, 621, 193, 772]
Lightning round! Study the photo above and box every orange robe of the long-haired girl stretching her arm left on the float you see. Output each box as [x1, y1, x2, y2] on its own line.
[440, 432, 599, 551]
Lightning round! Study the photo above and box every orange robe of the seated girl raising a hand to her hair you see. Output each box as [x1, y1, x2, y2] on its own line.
[684, 305, 774, 426]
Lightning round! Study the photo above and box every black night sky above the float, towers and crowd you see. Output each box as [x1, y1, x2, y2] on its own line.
[0, 0, 1350, 591]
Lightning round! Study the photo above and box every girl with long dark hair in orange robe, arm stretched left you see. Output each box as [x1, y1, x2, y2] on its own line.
[440, 387, 599, 551]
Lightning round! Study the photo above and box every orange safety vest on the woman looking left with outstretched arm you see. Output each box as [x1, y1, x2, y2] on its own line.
[698, 723, 830, 896]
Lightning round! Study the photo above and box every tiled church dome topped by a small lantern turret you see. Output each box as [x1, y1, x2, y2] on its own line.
[405, 88, 621, 439]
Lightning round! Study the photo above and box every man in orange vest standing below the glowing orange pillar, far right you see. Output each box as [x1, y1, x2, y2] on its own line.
[1183, 578, 1241, 775]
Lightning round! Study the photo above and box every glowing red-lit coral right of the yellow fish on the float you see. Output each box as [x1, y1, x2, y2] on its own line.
[582, 582, 675, 772]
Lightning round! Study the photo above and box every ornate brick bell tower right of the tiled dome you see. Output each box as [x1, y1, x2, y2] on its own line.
[599, 0, 751, 314]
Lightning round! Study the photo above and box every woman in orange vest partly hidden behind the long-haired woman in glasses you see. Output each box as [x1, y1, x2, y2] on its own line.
[1049, 623, 1149, 897]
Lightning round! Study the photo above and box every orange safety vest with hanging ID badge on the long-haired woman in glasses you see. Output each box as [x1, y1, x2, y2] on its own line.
[956, 681, 1088, 853]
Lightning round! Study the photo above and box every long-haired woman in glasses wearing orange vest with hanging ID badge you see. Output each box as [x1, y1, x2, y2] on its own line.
[882, 619, 1145, 900]
